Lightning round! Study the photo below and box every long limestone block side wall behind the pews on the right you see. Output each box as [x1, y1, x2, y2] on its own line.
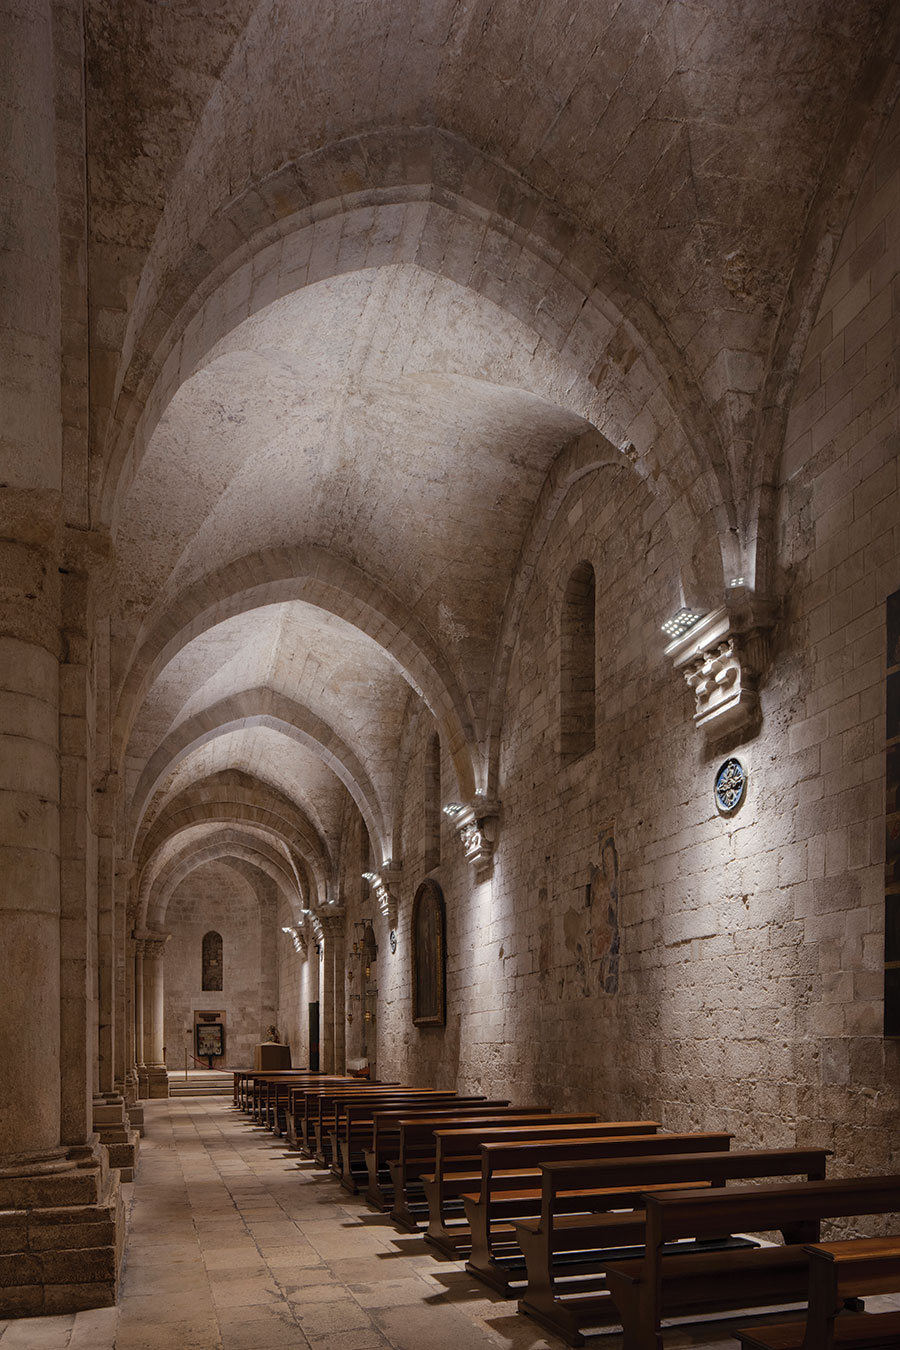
[379, 97, 900, 1170]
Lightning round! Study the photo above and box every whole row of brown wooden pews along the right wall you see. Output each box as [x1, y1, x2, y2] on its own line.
[235, 1069, 900, 1350]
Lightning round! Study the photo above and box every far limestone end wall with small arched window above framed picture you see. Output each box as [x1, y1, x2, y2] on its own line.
[165, 861, 277, 1072]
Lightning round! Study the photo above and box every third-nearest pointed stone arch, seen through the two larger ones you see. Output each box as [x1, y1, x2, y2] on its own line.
[131, 689, 391, 857]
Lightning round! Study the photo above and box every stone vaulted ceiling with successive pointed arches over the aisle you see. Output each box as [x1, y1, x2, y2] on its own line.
[88, 0, 896, 898]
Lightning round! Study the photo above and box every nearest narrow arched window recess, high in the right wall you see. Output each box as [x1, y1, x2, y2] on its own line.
[560, 563, 596, 763]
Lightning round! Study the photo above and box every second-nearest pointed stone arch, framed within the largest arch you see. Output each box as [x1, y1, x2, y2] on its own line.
[115, 545, 483, 797]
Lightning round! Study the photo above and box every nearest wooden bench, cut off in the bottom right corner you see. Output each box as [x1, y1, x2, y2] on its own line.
[734, 1237, 900, 1350]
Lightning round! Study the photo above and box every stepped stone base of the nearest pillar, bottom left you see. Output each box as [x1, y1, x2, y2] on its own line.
[0, 1149, 125, 1318]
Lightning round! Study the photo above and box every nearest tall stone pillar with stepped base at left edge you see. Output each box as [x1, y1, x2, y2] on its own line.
[0, 0, 124, 1306]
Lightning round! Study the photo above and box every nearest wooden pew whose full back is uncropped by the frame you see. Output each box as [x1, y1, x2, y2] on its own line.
[507, 1135, 830, 1345]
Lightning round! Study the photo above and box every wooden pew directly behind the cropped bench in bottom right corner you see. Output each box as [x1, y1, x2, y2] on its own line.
[593, 1176, 900, 1350]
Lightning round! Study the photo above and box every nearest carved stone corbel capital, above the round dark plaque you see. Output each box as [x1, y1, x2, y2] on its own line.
[665, 593, 775, 741]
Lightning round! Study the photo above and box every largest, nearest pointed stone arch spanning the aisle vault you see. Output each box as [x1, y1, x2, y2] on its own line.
[97, 127, 737, 588]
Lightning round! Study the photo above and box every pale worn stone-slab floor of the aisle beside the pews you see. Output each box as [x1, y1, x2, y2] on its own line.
[0, 1099, 900, 1350]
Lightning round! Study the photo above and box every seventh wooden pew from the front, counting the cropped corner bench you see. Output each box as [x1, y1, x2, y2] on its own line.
[364, 1102, 552, 1212]
